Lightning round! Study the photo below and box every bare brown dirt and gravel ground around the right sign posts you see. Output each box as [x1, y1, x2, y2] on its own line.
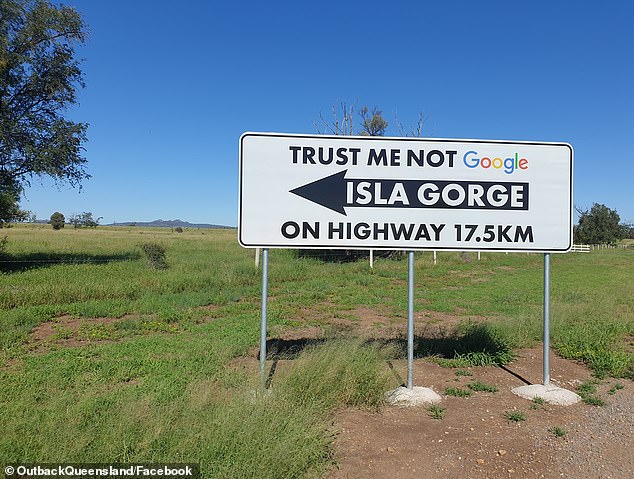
[329, 348, 634, 479]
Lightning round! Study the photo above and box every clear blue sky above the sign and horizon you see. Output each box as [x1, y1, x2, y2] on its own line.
[21, 0, 634, 226]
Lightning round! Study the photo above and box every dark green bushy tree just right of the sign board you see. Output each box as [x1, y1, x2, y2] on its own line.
[574, 203, 624, 244]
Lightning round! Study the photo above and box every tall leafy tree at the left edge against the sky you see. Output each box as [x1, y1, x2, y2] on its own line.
[0, 0, 90, 221]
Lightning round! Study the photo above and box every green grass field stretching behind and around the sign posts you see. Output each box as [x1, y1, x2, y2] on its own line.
[0, 226, 634, 478]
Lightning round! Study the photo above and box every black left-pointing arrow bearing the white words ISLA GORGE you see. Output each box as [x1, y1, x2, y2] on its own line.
[290, 170, 528, 216]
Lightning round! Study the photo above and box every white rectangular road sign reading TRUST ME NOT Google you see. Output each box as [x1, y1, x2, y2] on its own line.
[238, 133, 573, 252]
